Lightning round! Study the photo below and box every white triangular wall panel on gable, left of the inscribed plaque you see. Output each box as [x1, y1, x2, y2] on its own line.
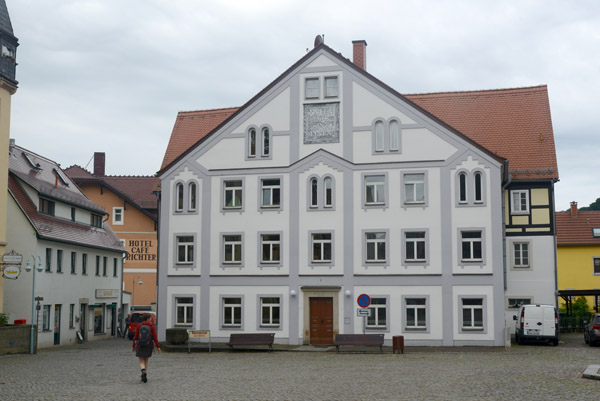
[232, 88, 291, 134]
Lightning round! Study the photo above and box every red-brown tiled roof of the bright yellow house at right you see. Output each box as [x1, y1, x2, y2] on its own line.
[555, 211, 600, 246]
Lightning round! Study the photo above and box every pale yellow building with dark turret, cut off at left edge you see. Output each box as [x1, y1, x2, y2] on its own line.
[0, 0, 19, 312]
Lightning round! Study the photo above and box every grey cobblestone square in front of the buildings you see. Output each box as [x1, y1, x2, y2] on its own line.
[0, 334, 600, 401]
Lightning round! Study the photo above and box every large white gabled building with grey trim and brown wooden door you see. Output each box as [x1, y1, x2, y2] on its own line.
[158, 38, 554, 346]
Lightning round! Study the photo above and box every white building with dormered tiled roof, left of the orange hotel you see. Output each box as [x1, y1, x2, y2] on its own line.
[4, 146, 125, 347]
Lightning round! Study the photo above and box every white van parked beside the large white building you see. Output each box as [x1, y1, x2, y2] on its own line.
[513, 305, 558, 345]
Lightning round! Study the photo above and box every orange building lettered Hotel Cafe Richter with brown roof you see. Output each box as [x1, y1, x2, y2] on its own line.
[65, 152, 158, 311]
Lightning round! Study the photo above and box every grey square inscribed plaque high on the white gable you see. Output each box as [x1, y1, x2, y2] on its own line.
[304, 103, 340, 144]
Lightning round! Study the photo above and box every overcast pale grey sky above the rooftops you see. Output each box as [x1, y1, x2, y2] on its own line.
[6, 0, 600, 210]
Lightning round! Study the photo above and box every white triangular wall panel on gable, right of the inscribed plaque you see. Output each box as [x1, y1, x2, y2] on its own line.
[352, 82, 416, 127]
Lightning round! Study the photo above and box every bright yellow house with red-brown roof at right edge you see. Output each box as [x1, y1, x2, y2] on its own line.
[556, 202, 600, 312]
